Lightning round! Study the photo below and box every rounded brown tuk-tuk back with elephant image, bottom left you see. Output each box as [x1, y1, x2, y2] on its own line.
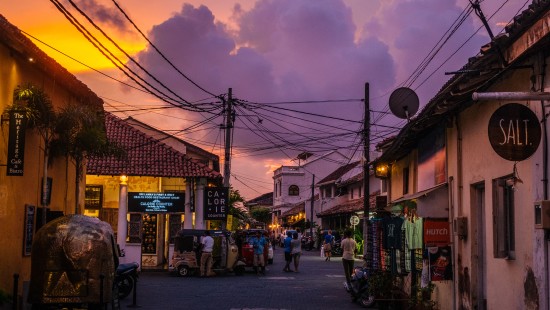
[28, 215, 118, 309]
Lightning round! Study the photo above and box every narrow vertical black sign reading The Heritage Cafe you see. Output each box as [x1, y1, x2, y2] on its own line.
[6, 111, 27, 176]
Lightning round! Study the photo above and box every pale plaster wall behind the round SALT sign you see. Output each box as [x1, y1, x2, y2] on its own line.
[447, 64, 542, 309]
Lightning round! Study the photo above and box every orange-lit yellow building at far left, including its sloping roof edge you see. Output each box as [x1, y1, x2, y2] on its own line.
[0, 16, 103, 300]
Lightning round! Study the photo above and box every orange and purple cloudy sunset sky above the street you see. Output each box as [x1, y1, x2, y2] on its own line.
[0, 0, 531, 199]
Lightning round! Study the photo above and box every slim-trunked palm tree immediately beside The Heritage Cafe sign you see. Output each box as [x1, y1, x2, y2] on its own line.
[6, 84, 56, 225]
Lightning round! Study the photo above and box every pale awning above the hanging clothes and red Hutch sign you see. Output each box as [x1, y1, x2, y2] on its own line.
[392, 183, 449, 218]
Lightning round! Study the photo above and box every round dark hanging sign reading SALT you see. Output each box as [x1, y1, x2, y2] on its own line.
[489, 103, 542, 161]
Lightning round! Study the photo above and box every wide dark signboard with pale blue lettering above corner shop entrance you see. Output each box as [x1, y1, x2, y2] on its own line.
[128, 192, 185, 213]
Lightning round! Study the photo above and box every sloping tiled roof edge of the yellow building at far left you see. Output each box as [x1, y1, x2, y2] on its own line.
[0, 15, 103, 107]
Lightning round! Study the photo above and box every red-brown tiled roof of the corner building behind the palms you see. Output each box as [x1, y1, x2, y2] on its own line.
[86, 112, 222, 178]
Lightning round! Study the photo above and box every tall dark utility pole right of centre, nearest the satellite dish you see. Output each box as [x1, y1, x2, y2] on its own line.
[363, 83, 372, 270]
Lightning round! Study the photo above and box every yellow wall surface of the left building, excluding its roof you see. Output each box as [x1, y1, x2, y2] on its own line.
[0, 44, 83, 293]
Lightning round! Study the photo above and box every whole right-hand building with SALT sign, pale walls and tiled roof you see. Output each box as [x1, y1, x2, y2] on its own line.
[375, 1, 550, 309]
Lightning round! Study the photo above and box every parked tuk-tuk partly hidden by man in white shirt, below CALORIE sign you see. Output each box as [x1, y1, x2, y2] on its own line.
[169, 229, 244, 277]
